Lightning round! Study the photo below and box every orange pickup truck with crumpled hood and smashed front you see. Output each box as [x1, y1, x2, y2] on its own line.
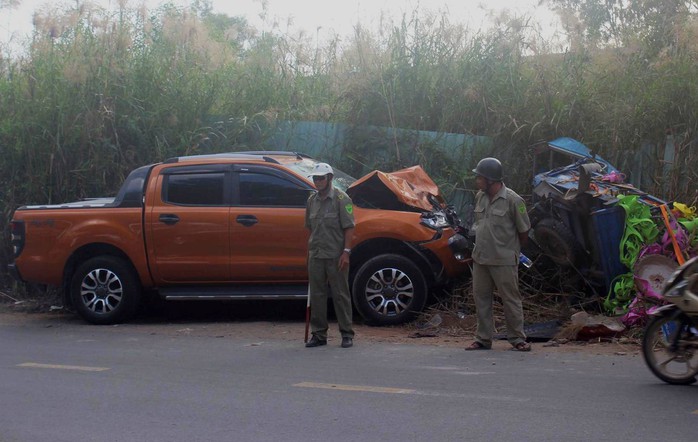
[9, 152, 469, 325]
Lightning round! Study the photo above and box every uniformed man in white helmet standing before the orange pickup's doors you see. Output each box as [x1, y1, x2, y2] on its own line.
[305, 163, 354, 348]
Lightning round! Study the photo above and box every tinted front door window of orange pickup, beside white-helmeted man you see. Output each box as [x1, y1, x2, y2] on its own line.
[240, 172, 310, 207]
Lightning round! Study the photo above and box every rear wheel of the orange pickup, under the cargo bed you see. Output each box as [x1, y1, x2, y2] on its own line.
[70, 256, 141, 325]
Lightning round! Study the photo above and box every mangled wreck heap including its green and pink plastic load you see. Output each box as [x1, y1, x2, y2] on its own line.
[525, 138, 698, 325]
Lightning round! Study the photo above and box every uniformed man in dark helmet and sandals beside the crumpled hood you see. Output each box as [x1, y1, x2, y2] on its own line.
[465, 158, 531, 351]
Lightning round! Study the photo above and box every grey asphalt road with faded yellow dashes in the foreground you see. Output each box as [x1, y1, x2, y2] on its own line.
[0, 310, 698, 442]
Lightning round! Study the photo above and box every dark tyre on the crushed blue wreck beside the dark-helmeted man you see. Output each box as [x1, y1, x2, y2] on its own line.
[533, 218, 583, 267]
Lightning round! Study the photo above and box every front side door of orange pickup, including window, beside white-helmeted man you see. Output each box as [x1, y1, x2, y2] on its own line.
[230, 166, 312, 282]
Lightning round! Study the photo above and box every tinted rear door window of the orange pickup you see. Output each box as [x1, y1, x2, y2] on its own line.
[162, 173, 225, 206]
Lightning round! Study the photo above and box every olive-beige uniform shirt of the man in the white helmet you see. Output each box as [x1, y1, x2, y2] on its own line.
[305, 187, 354, 259]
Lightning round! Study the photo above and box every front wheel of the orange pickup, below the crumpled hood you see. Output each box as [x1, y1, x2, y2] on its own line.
[352, 254, 427, 325]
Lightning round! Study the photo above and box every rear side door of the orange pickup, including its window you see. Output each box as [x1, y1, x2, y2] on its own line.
[146, 164, 231, 283]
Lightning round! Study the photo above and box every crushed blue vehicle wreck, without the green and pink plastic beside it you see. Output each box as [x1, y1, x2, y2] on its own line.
[525, 138, 666, 296]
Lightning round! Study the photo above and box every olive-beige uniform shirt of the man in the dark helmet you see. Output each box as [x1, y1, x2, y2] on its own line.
[472, 185, 531, 265]
